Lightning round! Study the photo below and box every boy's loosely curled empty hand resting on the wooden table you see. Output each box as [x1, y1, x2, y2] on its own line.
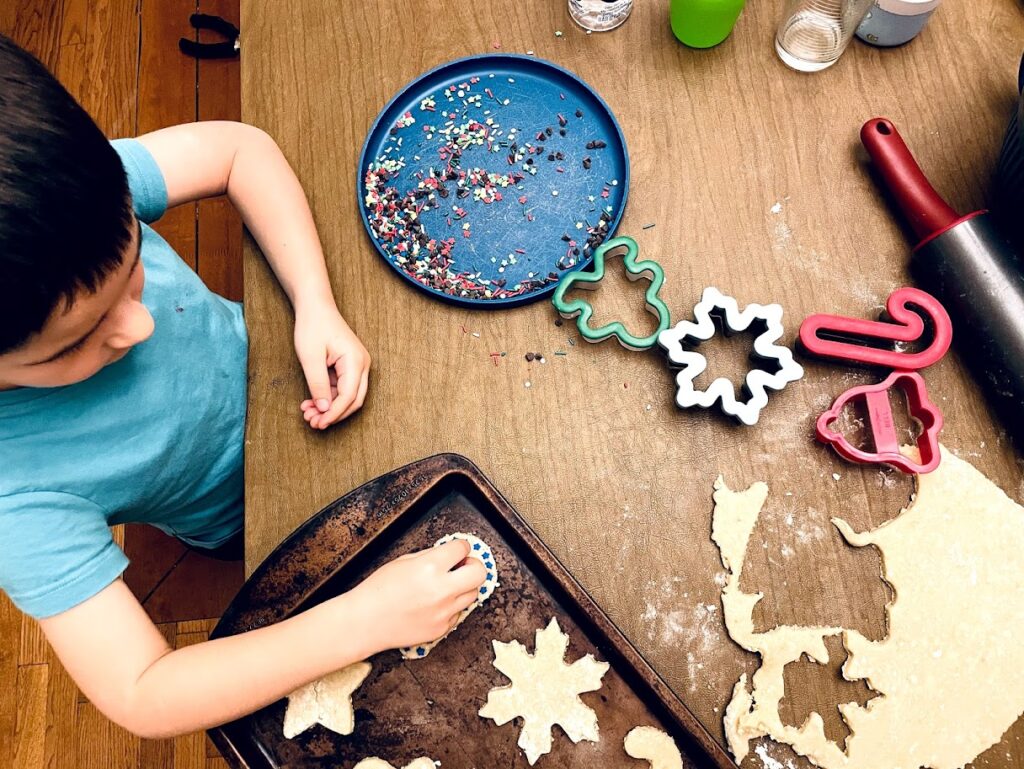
[295, 302, 370, 430]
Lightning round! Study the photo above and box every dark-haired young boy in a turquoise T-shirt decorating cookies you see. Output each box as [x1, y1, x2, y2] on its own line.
[0, 36, 484, 737]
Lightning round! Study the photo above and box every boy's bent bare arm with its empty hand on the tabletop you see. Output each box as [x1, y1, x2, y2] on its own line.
[138, 121, 370, 429]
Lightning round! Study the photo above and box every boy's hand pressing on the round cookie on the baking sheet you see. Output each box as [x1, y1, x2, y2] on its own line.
[348, 540, 487, 654]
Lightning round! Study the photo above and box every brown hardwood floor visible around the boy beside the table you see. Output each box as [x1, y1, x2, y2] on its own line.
[0, 0, 242, 769]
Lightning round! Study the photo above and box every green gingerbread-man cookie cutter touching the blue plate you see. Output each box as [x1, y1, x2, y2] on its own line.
[551, 236, 670, 350]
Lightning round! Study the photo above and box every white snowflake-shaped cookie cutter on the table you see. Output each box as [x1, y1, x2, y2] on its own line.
[657, 287, 804, 425]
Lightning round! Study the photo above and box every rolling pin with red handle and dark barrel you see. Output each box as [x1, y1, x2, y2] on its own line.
[860, 118, 1024, 452]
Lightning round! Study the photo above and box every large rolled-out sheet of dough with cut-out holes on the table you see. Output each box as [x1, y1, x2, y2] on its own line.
[712, 448, 1024, 769]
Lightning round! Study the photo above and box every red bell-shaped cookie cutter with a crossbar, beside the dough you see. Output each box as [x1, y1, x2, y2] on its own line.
[815, 371, 942, 473]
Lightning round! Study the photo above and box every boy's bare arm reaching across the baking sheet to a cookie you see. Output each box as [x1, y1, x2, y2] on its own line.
[40, 541, 486, 738]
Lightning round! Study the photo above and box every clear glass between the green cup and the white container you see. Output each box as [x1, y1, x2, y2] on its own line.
[775, 0, 874, 72]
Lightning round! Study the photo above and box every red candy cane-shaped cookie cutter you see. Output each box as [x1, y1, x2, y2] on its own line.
[800, 286, 953, 371]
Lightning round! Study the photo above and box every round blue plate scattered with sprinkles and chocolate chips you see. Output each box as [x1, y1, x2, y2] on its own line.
[358, 54, 630, 308]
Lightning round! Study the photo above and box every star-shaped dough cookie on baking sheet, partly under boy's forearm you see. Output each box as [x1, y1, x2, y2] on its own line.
[283, 663, 372, 739]
